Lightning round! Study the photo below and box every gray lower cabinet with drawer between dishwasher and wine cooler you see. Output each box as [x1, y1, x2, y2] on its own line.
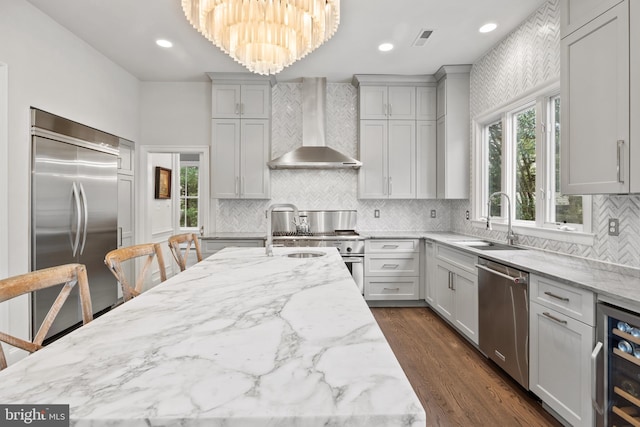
[529, 275, 594, 426]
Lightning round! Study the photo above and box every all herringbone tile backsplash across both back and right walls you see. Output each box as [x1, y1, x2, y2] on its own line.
[213, 0, 640, 267]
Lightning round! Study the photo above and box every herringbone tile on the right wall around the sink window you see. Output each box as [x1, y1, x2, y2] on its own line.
[451, 0, 640, 267]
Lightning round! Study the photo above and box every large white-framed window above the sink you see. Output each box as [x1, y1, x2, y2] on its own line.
[475, 85, 591, 232]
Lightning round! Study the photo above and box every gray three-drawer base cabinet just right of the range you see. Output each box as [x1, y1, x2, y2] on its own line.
[364, 239, 420, 300]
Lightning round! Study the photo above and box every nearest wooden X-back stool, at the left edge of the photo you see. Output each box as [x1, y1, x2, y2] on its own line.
[0, 264, 93, 370]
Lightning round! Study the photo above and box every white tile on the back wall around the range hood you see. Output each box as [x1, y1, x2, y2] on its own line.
[214, 83, 450, 232]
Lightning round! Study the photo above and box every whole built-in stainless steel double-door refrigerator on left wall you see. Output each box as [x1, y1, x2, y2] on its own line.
[31, 109, 118, 338]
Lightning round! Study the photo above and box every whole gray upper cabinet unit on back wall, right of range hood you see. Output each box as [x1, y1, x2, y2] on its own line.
[354, 75, 436, 199]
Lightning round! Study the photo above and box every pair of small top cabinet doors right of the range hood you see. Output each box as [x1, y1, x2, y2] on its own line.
[360, 86, 416, 120]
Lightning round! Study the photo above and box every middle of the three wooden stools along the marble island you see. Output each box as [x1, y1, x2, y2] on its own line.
[104, 243, 167, 302]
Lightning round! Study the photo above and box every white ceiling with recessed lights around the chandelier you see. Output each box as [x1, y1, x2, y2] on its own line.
[23, 0, 546, 82]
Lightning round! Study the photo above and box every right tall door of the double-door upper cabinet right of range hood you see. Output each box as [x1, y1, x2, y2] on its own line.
[388, 120, 416, 199]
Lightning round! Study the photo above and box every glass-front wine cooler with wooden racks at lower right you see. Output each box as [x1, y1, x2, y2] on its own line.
[591, 302, 640, 427]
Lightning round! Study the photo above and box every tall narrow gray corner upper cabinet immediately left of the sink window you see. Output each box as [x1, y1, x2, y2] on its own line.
[436, 65, 471, 199]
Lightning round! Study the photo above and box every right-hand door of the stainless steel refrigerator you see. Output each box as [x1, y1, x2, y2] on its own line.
[77, 147, 118, 313]
